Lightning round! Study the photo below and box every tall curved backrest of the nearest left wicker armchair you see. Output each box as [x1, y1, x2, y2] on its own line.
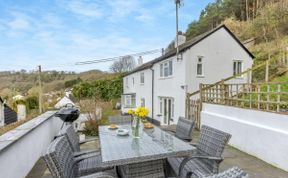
[43, 136, 78, 178]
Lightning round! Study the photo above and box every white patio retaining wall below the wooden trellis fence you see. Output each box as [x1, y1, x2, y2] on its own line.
[201, 103, 288, 171]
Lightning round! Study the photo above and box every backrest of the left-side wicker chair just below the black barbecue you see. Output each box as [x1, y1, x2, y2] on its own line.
[60, 125, 80, 152]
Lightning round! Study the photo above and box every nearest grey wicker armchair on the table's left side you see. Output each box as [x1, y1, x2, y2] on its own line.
[43, 136, 117, 178]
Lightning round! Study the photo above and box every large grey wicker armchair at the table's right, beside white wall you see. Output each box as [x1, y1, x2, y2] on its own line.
[167, 125, 231, 177]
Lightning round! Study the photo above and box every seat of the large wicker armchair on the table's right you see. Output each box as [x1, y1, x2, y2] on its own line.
[167, 158, 212, 177]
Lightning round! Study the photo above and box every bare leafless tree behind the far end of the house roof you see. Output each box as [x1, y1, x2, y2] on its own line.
[110, 56, 136, 73]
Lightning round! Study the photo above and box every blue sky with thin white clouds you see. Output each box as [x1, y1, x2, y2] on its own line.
[0, 0, 213, 71]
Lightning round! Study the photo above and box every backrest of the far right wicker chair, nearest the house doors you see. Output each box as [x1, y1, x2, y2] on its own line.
[175, 117, 194, 140]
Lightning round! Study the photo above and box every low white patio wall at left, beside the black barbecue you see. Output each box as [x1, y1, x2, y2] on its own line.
[0, 111, 62, 178]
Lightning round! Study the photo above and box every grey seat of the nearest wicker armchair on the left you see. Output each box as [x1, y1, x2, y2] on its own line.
[78, 155, 113, 176]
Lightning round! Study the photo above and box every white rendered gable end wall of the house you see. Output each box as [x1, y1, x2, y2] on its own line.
[184, 28, 253, 93]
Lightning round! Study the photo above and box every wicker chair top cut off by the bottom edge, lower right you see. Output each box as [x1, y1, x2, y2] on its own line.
[205, 167, 249, 178]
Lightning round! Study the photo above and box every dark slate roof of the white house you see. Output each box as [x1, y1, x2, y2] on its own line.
[125, 24, 255, 76]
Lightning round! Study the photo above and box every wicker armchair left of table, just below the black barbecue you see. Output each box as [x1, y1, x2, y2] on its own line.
[57, 125, 100, 159]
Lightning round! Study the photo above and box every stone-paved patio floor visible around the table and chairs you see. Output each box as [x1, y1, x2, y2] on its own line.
[27, 126, 288, 178]
